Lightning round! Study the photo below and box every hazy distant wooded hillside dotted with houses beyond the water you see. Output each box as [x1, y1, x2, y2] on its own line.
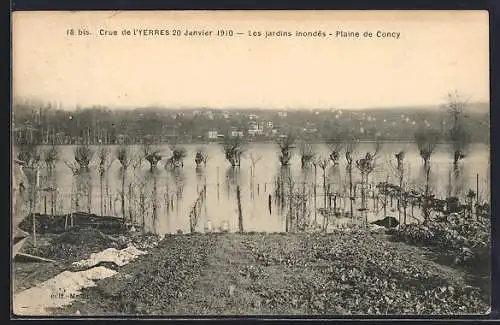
[12, 98, 489, 144]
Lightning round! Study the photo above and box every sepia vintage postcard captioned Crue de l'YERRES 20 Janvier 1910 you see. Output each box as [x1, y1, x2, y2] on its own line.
[11, 11, 491, 317]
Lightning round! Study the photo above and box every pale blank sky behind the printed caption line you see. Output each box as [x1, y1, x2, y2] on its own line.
[13, 11, 489, 109]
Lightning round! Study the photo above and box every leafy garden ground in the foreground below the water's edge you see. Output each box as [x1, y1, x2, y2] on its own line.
[28, 232, 490, 316]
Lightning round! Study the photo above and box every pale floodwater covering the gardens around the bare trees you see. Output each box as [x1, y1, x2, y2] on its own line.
[18, 143, 490, 234]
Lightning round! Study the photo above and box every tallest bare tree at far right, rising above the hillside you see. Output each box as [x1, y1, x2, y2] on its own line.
[446, 92, 470, 170]
